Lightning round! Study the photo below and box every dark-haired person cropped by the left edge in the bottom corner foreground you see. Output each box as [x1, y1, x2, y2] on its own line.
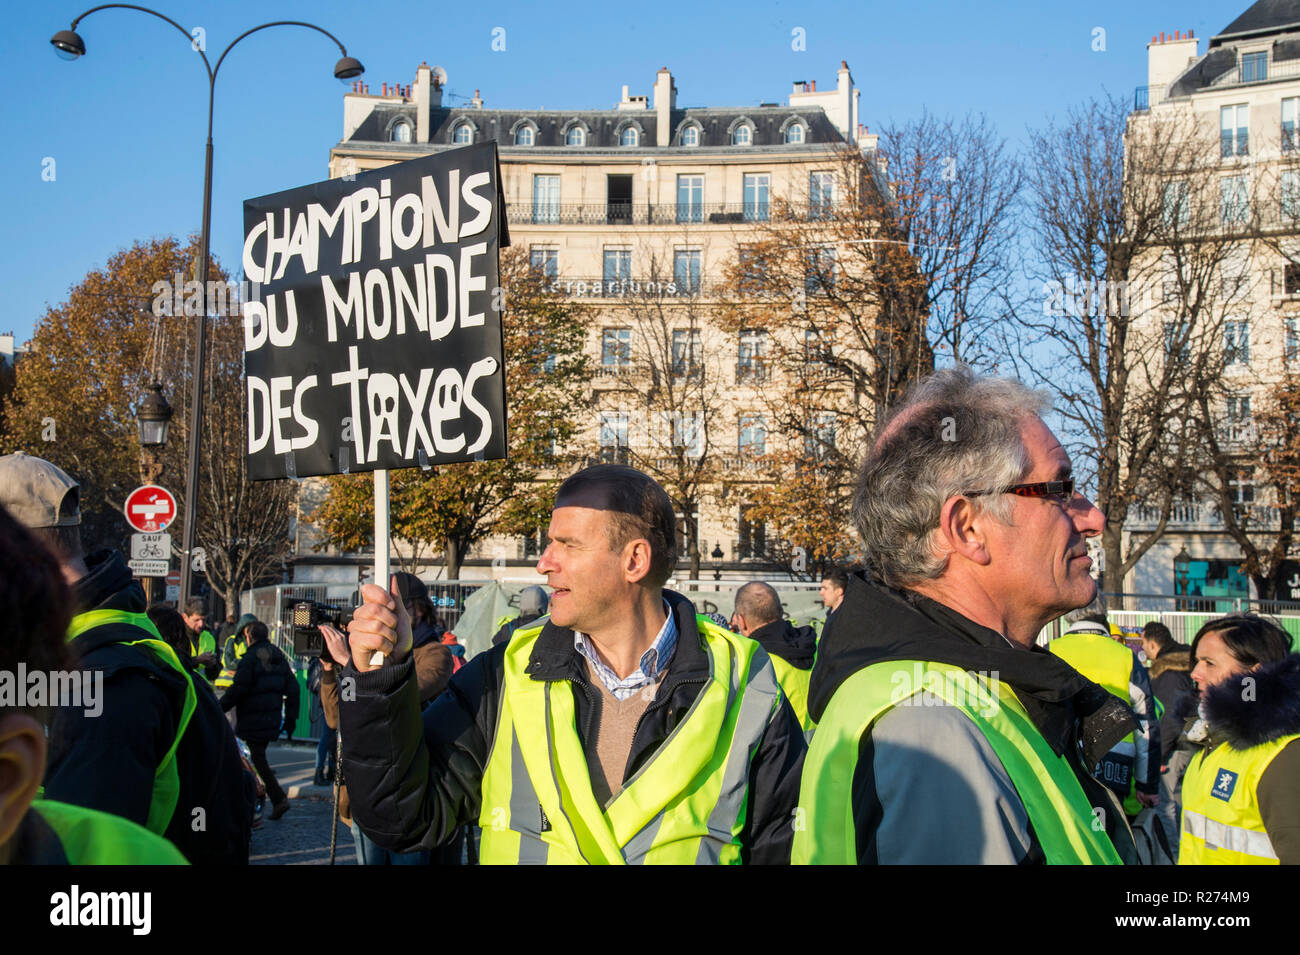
[0, 507, 185, 865]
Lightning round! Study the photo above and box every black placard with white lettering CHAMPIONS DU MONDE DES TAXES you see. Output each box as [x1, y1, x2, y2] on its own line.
[243, 143, 508, 479]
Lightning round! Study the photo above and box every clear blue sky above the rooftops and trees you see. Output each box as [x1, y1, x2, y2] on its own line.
[0, 0, 1248, 339]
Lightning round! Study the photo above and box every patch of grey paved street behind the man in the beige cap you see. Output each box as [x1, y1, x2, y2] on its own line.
[248, 743, 356, 865]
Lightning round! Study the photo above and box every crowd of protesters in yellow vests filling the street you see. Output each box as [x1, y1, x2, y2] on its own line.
[0, 368, 1300, 864]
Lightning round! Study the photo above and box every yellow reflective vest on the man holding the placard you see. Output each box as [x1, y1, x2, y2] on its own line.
[480, 617, 781, 865]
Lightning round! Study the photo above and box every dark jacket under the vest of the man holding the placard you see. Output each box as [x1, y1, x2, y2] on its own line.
[339, 590, 806, 864]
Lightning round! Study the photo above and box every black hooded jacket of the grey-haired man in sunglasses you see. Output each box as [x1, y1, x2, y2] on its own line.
[809, 573, 1136, 864]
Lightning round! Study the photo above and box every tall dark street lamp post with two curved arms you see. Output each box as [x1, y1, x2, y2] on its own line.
[49, 4, 365, 607]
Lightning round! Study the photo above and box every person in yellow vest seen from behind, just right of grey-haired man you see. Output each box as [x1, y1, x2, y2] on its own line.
[1048, 596, 1164, 816]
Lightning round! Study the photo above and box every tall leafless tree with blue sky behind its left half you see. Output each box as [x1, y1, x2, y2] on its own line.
[1017, 99, 1253, 590]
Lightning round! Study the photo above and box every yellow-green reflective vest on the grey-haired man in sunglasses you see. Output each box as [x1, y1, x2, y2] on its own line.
[792, 660, 1119, 865]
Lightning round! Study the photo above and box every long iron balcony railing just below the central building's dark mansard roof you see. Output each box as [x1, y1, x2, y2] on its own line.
[506, 201, 835, 226]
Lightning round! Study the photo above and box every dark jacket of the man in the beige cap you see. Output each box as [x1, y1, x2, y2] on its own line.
[46, 551, 250, 864]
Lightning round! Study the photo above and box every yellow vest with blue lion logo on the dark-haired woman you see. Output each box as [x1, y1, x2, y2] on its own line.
[1178, 733, 1300, 865]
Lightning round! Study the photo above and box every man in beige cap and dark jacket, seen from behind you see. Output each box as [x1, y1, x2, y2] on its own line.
[0, 452, 250, 863]
